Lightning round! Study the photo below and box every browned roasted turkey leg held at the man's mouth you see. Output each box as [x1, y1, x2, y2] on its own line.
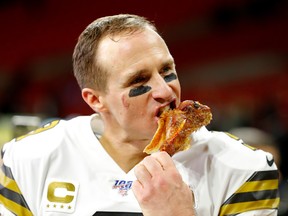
[144, 100, 212, 156]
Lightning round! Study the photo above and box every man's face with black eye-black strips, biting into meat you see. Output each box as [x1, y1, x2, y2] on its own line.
[97, 29, 180, 142]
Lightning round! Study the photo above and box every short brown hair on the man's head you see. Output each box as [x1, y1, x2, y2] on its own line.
[72, 14, 157, 91]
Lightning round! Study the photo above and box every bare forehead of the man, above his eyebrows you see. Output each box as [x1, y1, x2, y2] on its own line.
[96, 28, 173, 78]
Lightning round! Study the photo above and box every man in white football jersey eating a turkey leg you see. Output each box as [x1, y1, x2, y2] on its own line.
[0, 14, 279, 216]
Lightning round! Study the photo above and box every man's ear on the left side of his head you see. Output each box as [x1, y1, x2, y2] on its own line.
[82, 88, 105, 112]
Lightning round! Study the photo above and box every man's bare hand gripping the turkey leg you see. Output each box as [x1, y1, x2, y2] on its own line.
[132, 152, 195, 216]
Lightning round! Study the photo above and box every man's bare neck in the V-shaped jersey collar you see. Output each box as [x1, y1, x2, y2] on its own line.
[100, 134, 147, 173]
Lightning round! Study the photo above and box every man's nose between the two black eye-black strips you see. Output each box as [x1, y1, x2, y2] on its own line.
[152, 75, 173, 103]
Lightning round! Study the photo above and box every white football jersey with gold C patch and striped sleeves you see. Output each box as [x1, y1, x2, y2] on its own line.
[0, 115, 279, 216]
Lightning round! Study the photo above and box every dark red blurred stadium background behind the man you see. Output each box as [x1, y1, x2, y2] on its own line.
[0, 0, 288, 179]
